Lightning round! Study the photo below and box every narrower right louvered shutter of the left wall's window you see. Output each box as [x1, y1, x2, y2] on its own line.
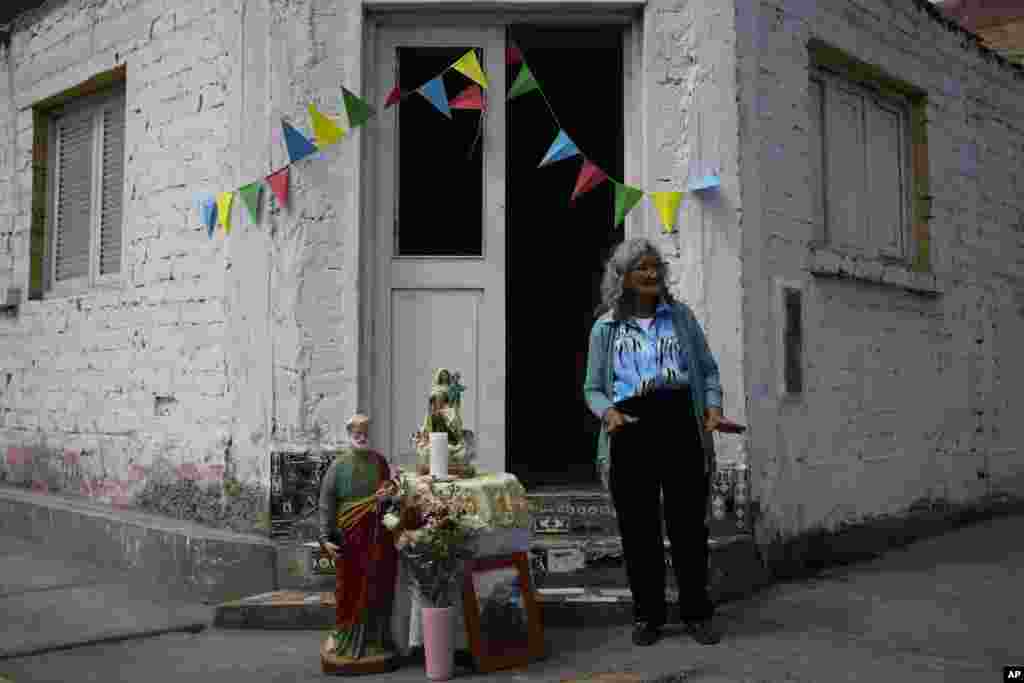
[98, 98, 125, 275]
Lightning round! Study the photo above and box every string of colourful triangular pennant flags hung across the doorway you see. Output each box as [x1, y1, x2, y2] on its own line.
[196, 44, 720, 239]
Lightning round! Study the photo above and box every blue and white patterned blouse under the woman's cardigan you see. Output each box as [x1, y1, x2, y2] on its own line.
[611, 304, 689, 403]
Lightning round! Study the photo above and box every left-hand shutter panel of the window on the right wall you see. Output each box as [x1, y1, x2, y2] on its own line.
[825, 83, 865, 249]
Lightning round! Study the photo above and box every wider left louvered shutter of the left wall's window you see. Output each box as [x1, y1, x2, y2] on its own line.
[53, 105, 94, 283]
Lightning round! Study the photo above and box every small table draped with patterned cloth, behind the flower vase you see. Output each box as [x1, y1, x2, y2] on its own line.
[392, 472, 530, 653]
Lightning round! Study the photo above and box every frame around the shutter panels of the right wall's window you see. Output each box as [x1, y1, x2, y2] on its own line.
[808, 65, 916, 267]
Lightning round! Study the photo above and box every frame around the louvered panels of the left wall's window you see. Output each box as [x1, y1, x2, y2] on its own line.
[42, 83, 128, 298]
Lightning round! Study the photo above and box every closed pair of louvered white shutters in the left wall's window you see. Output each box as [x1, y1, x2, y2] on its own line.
[50, 87, 125, 288]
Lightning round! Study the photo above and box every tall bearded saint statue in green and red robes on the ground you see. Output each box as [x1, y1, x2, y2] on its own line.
[319, 415, 398, 674]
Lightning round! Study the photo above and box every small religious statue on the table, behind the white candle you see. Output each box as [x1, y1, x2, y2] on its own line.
[415, 368, 476, 478]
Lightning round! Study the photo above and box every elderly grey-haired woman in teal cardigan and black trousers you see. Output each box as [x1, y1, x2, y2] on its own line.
[584, 239, 722, 645]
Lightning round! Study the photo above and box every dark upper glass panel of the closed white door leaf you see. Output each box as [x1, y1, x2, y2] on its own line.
[394, 47, 483, 256]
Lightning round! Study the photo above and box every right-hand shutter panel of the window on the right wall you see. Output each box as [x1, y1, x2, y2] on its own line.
[863, 100, 905, 257]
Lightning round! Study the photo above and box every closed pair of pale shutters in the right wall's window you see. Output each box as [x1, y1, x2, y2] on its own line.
[808, 72, 909, 258]
